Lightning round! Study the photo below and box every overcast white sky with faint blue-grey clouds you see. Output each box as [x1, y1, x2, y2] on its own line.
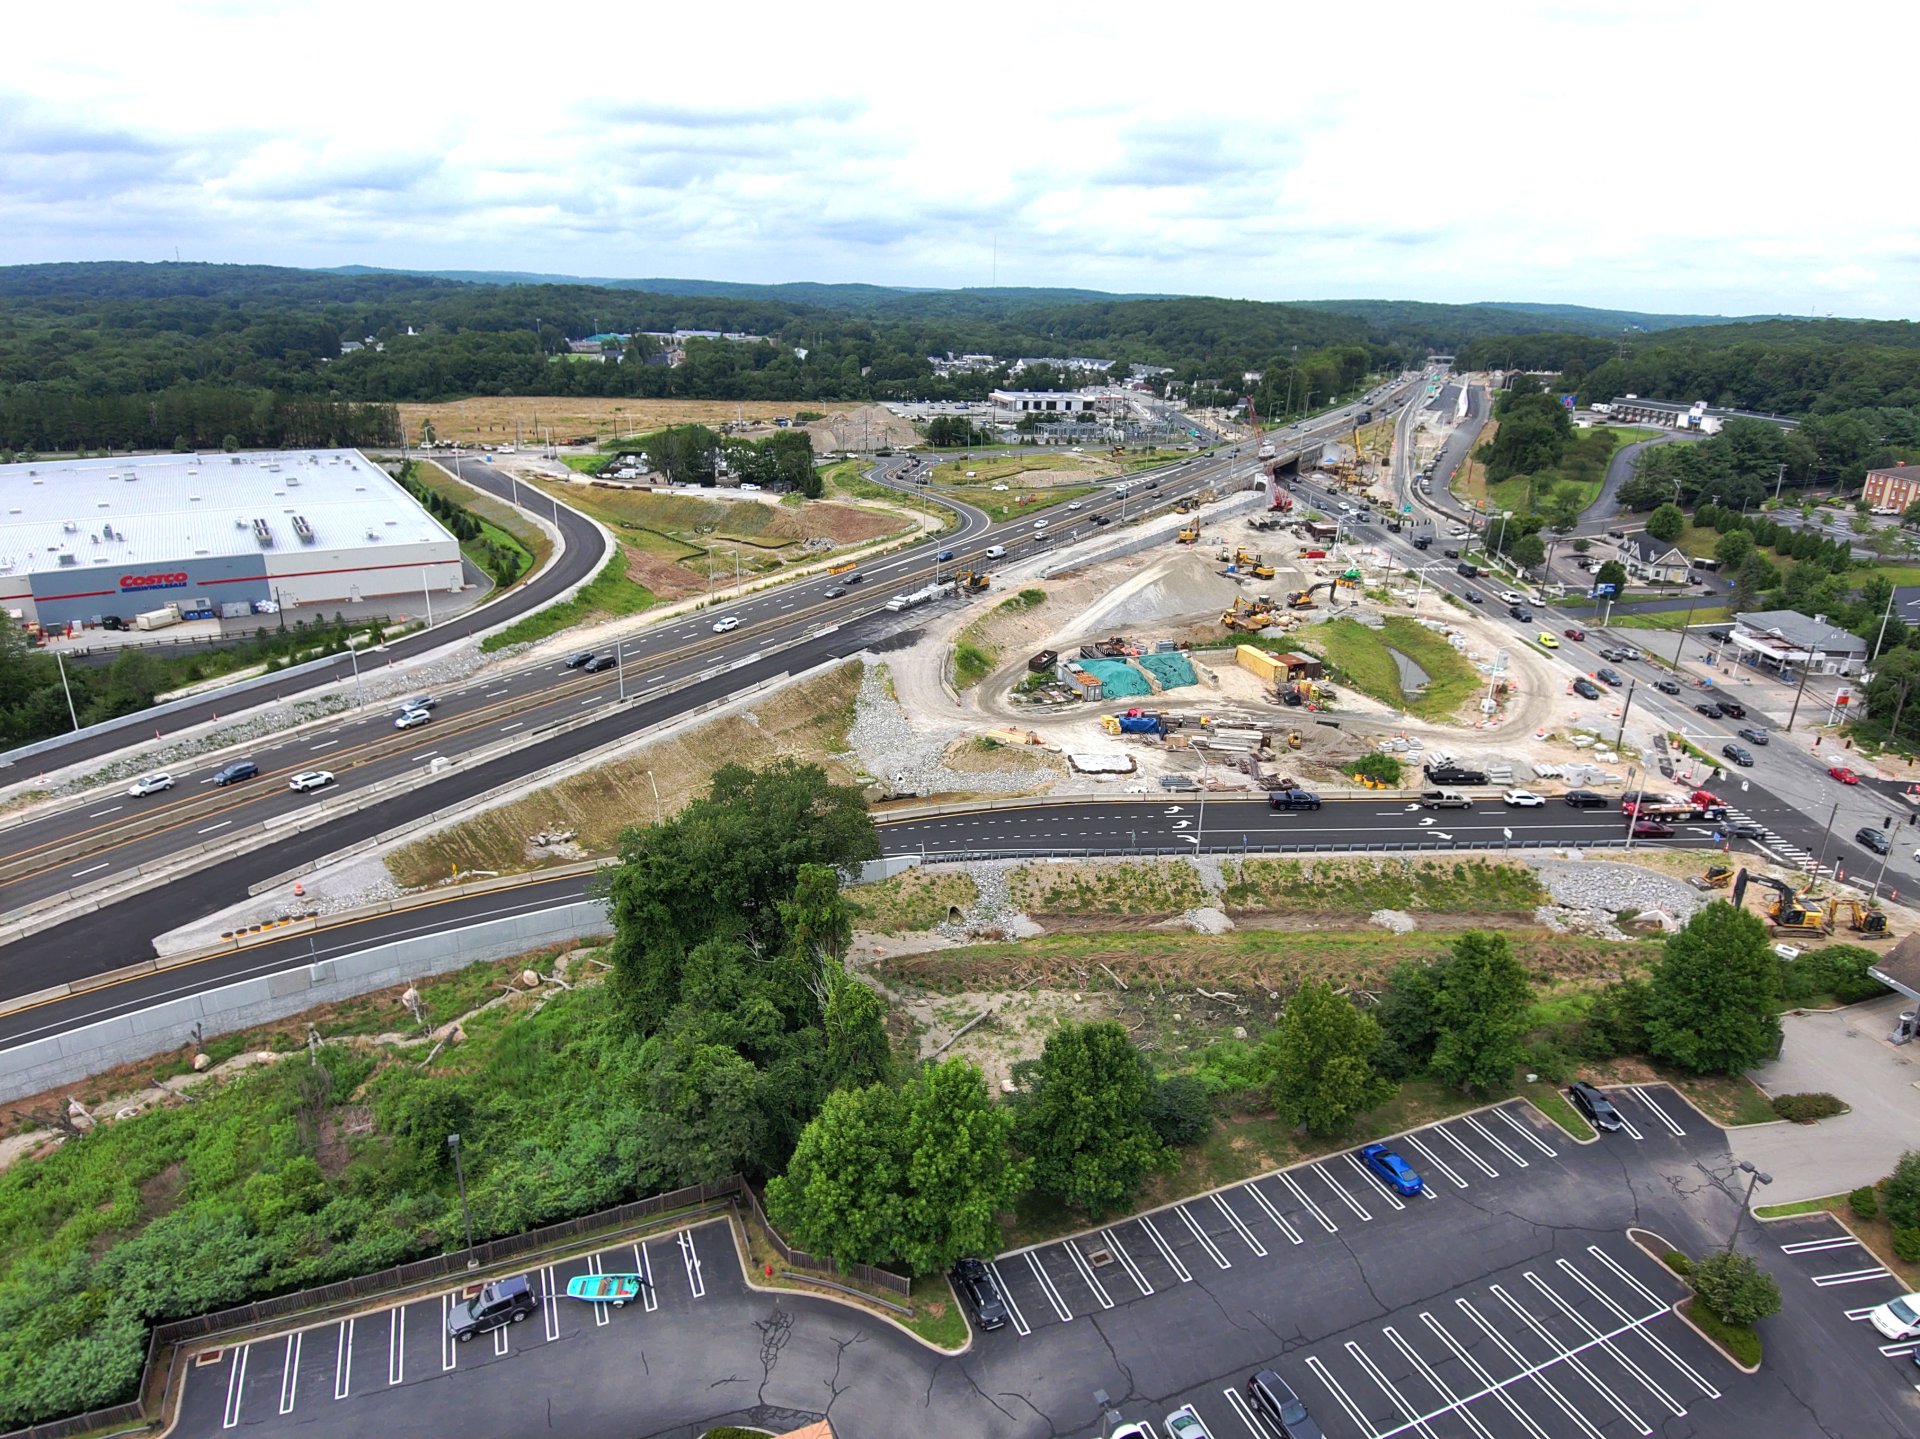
[0, 0, 1920, 317]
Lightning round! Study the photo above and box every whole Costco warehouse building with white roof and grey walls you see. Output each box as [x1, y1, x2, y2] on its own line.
[0, 450, 463, 628]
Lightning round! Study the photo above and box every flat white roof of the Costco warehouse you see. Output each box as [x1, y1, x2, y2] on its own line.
[0, 450, 451, 574]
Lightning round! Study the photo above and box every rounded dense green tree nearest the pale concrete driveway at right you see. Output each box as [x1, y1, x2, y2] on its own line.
[1647, 901, 1780, 1074]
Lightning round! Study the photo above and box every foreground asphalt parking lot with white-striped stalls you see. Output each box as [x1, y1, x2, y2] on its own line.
[165, 1085, 1920, 1439]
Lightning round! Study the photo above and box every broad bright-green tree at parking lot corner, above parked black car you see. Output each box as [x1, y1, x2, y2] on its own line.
[766, 1059, 1027, 1274]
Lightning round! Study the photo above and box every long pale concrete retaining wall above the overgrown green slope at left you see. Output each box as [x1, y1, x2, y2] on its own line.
[0, 899, 612, 1101]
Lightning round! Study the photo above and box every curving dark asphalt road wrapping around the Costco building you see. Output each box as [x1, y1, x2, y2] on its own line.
[0, 457, 607, 765]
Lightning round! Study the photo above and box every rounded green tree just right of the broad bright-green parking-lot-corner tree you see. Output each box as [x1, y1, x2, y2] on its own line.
[1016, 1020, 1167, 1216]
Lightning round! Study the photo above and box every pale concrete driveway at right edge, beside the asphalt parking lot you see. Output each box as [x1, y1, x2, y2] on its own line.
[1726, 995, 1920, 1205]
